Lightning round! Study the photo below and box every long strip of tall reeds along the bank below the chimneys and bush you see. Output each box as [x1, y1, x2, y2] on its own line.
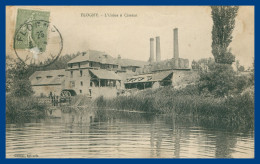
[95, 85, 254, 129]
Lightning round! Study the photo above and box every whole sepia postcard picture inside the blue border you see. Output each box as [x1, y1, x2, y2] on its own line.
[5, 6, 255, 159]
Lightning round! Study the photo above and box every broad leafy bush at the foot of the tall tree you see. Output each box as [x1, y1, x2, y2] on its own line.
[198, 59, 253, 97]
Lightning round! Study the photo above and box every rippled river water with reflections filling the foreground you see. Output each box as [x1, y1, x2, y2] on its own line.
[6, 109, 254, 158]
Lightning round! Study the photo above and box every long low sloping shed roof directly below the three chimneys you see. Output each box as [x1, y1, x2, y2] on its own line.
[126, 71, 173, 83]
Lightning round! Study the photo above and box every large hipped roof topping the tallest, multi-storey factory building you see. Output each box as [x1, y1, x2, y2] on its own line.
[68, 50, 117, 65]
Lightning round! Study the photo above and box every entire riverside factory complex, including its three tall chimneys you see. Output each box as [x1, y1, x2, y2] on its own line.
[30, 29, 196, 98]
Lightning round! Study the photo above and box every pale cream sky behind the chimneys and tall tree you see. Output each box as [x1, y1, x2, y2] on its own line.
[6, 6, 254, 67]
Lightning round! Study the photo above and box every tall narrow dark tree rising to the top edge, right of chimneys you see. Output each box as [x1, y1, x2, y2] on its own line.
[211, 6, 239, 64]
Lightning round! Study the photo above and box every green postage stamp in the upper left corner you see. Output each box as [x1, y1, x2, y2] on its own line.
[14, 9, 50, 52]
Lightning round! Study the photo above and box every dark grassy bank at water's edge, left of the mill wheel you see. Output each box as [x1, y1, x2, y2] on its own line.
[6, 96, 46, 122]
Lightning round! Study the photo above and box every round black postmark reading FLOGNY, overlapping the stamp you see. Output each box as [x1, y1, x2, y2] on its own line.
[13, 20, 63, 67]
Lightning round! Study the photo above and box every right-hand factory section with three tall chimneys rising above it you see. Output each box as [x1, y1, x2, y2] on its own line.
[125, 28, 198, 89]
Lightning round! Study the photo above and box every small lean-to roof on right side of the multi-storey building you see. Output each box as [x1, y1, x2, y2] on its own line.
[89, 70, 121, 80]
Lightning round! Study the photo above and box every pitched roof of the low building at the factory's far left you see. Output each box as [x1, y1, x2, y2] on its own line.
[29, 69, 66, 86]
